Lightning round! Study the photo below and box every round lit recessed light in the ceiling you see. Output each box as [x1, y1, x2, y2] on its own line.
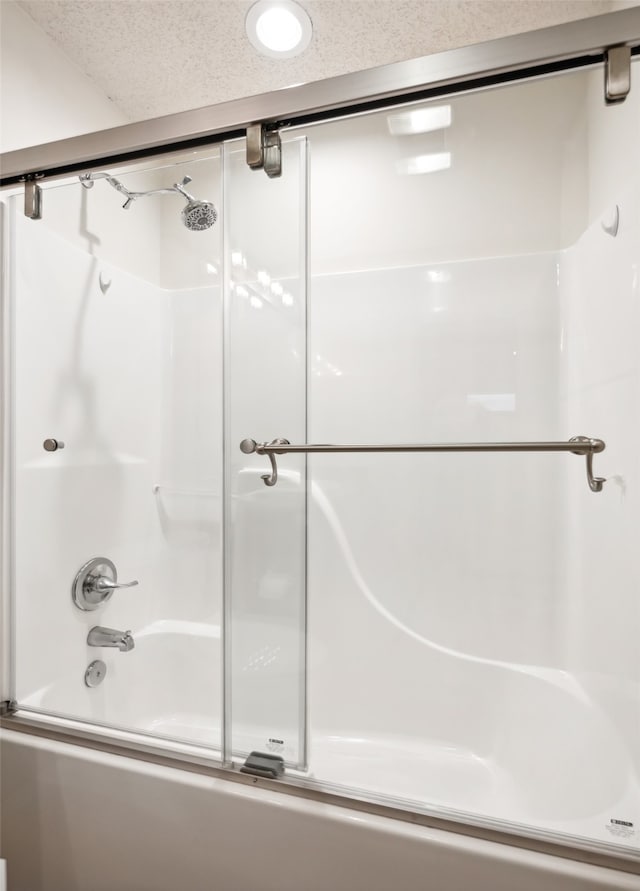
[244, 0, 312, 59]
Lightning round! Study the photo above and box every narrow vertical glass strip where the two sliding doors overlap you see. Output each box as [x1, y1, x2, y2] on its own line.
[225, 139, 306, 766]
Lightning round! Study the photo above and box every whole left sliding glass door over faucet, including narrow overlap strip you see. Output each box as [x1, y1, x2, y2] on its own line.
[11, 138, 307, 767]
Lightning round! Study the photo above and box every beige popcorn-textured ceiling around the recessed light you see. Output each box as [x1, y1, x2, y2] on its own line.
[18, 0, 640, 121]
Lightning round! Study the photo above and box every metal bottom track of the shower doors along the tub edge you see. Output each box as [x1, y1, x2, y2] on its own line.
[0, 702, 640, 875]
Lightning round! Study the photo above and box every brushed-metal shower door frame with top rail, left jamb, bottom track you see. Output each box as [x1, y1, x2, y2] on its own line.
[0, 8, 640, 874]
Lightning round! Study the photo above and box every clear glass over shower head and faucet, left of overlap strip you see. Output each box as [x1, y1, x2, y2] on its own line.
[12, 149, 222, 747]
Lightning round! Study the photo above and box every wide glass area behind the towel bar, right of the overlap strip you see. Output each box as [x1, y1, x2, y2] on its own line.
[308, 62, 640, 854]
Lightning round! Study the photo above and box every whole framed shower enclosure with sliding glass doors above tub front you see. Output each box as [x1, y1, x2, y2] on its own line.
[2, 9, 640, 888]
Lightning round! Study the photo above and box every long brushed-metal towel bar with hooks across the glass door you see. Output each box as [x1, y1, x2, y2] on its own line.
[240, 436, 606, 492]
